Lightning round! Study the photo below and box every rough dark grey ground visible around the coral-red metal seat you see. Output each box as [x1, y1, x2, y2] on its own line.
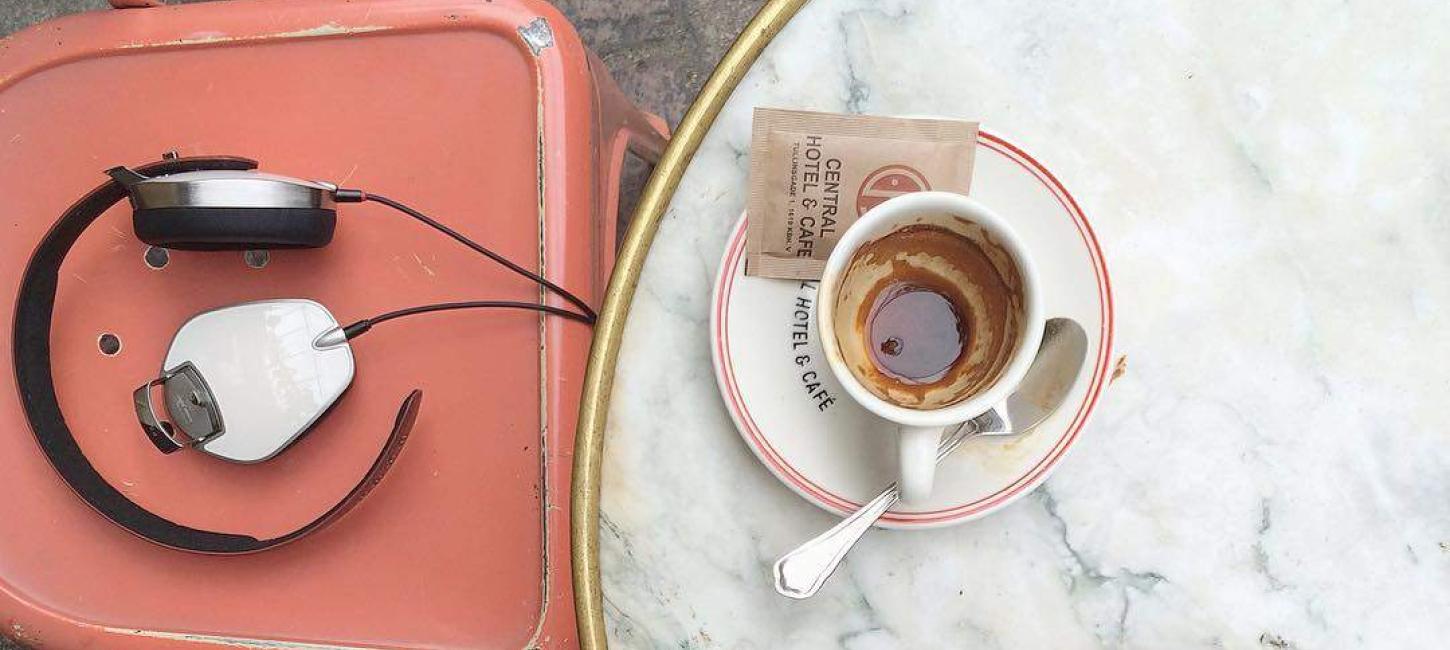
[0, 0, 761, 650]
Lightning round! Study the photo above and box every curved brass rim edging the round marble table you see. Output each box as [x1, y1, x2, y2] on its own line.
[570, 0, 808, 650]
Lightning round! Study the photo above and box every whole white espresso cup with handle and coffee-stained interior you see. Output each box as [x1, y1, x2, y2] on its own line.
[816, 192, 1044, 503]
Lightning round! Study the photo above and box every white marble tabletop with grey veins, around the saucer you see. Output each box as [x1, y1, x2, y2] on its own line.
[602, 0, 1450, 649]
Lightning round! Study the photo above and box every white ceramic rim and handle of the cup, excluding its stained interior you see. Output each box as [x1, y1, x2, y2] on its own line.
[816, 192, 1044, 503]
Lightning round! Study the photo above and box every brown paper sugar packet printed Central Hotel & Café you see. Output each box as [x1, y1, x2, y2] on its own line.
[745, 109, 977, 280]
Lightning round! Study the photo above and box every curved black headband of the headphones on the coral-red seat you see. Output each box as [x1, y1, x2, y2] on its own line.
[13, 157, 423, 554]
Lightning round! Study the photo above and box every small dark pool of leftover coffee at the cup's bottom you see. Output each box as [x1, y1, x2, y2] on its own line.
[867, 284, 967, 384]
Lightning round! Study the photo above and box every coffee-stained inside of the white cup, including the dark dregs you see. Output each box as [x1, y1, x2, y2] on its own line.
[835, 221, 1024, 409]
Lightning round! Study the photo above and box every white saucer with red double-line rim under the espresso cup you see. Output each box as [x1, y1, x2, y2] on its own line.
[711, 132, 1114, 528]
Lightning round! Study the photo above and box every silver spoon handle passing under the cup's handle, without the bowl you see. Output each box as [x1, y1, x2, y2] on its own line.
[774, 422, 980, 599]
